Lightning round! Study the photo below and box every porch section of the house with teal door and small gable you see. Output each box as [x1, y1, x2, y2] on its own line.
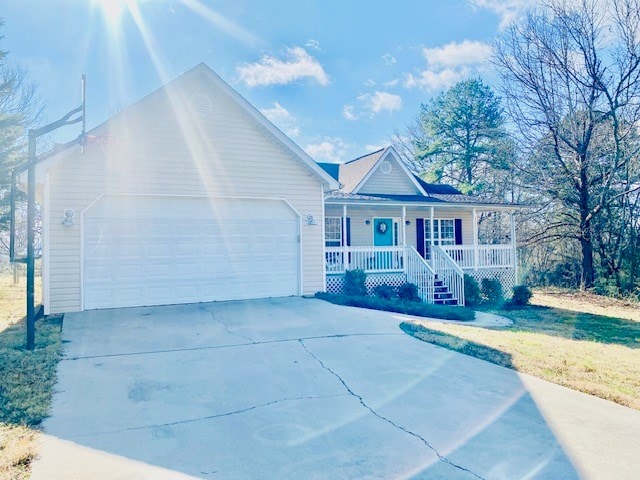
[319, 147, 518, 305]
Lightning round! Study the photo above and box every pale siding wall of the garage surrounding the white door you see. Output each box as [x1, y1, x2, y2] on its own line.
[47, 68, 324, 313]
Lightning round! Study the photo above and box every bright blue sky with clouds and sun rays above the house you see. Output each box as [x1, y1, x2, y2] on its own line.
[0, 0, 529, 161]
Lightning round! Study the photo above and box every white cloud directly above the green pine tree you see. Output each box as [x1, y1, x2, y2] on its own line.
[404, 40, 491, 91]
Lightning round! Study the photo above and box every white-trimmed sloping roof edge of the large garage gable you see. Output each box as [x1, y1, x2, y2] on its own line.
[21, 63, 339, 190]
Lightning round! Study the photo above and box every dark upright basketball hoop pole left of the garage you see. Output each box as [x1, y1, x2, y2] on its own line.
[27, 130, 37, 350]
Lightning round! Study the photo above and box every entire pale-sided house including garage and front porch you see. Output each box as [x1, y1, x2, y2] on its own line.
[20, 64, 516, 314]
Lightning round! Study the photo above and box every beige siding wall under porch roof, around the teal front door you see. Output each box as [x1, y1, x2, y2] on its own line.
[325, 205, 473, 249]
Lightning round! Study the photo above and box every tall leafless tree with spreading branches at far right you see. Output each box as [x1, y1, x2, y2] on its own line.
[494, 0, 640, 288]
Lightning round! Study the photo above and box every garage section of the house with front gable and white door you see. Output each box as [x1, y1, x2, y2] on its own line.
[27, 64, 338, 313]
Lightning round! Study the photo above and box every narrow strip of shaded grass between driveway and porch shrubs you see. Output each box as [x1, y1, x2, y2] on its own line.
[316, 292, 475, 322]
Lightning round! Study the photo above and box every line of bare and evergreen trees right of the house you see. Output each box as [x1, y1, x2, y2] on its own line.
[394, 0, 640, 297]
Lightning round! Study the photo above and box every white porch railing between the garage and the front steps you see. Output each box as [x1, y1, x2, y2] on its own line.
[325, 246, 405, 273]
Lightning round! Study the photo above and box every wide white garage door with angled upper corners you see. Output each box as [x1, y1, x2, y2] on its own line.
[83, 196, 300, 309]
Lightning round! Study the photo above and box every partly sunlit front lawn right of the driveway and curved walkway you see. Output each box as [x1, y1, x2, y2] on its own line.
[401, 295, 640, 410]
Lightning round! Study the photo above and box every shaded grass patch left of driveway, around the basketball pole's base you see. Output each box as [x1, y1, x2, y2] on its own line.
[0, 317, 62, 426]
